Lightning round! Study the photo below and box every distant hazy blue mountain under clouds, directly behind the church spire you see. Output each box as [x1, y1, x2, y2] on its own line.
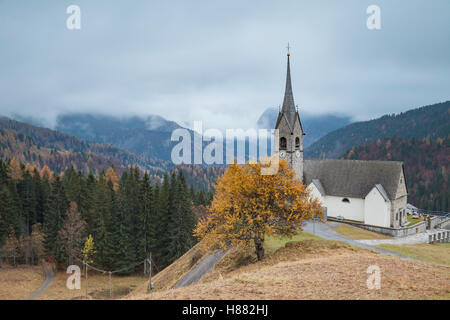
[257, 108, 351, 148]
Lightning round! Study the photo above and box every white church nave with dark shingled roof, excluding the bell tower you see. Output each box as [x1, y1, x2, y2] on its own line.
[303, 159, 408, 228]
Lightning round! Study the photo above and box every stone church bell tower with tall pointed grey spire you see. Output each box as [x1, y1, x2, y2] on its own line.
[275, 44, 305, 181]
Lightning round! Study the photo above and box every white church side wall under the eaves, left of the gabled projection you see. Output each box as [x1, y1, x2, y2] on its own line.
[324, 196, 364, 221]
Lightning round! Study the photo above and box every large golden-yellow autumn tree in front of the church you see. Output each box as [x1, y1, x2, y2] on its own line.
[195, 160, 322, 260]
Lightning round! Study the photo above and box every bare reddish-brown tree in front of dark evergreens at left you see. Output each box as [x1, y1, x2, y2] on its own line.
[58, 201, 86, 265]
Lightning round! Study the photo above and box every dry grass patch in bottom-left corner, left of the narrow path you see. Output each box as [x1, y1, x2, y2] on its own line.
[0, 266, 45, 300]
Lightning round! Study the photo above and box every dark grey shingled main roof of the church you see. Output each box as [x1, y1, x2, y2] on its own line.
[303, 159, 403, 200]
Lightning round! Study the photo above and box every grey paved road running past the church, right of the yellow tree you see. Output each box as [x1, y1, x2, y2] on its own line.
[303, 221, 410, 259]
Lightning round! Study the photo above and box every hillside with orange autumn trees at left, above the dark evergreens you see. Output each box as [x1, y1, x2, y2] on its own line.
[0, 117, 172, 172]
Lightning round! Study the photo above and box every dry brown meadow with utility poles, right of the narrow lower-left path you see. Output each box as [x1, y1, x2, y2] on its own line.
[37, 271, 148, 300]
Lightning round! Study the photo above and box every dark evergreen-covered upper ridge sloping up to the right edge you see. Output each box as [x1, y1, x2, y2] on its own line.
[305, 101, 450, 158]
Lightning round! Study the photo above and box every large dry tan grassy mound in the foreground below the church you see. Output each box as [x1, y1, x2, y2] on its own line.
[135, 240, 450, 300]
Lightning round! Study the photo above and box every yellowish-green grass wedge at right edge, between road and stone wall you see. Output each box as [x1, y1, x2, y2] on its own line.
[378, 243, 450, 266]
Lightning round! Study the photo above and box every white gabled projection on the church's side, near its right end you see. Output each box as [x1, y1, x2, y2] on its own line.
[364, 188, 391, 228]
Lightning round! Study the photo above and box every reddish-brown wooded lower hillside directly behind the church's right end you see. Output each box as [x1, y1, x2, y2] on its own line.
[343, 134, 450, 212]
